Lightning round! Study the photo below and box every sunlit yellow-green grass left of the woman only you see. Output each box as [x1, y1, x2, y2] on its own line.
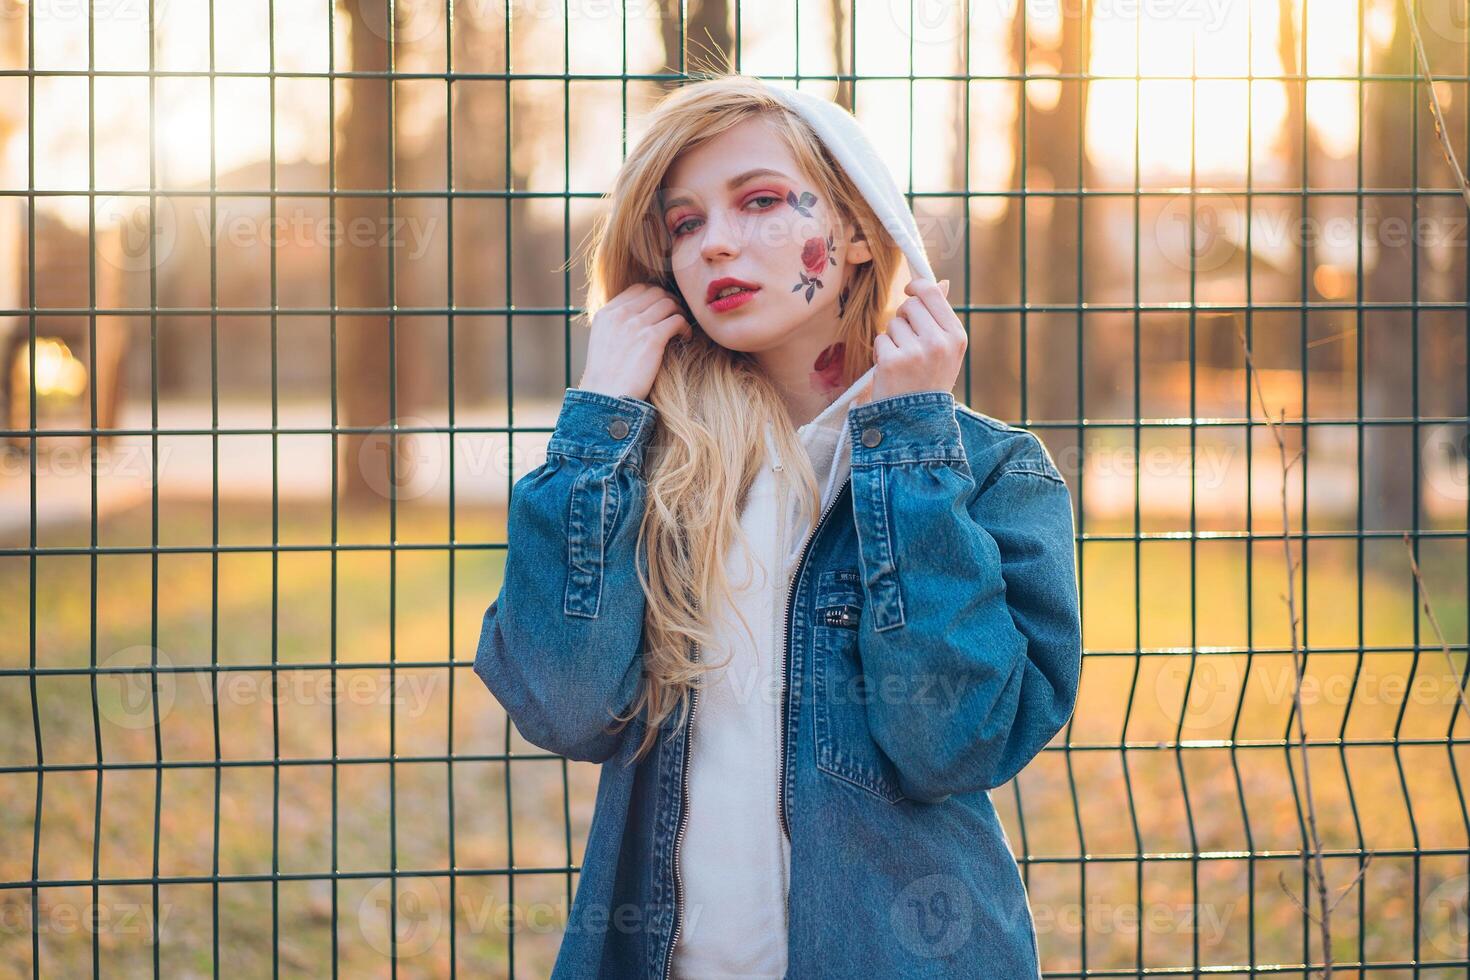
[0, 502, 597, 976]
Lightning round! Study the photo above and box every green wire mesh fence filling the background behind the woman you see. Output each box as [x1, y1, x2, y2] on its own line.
[0, 0, 1470, 977]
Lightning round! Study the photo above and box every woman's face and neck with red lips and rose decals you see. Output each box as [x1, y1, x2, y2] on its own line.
[660, 116, 872, 399]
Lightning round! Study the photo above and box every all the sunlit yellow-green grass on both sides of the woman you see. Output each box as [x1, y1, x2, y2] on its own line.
[0, 502, 1470, 977]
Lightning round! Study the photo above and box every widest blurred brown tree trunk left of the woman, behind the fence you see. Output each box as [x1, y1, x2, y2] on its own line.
[335, 0, 415, 502]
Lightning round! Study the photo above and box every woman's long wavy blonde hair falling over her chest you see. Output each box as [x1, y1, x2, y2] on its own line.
[573, 72, 903, 761]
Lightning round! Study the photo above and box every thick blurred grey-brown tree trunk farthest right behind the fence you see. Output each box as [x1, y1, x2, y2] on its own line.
[1358, 3, 1417, 530]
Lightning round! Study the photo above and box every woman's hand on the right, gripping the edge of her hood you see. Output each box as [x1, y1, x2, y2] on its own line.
[863, 278, 969, 403]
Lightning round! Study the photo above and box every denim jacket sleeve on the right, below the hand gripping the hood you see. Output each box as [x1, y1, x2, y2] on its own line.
[848, 391, 1082, 801]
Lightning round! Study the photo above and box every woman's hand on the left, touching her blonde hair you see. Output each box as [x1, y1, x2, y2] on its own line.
[578, 282, 694, 398]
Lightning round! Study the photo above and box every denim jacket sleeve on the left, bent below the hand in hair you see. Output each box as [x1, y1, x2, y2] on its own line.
[475, 388, 656, 763]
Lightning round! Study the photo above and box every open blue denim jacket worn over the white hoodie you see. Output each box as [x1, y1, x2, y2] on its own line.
[475, 388, 1082, 980]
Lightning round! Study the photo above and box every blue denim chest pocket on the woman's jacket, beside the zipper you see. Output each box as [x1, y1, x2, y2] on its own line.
[811, 569, 906, 804]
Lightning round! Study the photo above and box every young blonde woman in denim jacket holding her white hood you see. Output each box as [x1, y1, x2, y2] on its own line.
[475, 75, 1082, 980]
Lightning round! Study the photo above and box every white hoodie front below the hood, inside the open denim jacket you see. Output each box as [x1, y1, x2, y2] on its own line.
[673, 369, 875, 980]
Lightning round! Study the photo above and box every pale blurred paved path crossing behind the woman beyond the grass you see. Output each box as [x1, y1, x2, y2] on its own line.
[0, 398, 1466, 541]
